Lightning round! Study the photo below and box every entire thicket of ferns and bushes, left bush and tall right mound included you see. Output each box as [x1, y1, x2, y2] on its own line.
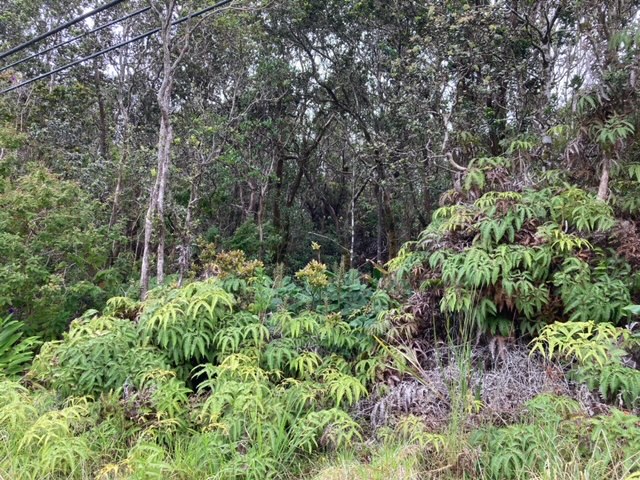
[0, 145, 640, 480]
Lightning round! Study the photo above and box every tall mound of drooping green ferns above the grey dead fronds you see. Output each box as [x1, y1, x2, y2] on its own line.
[388, 163, 634, 336]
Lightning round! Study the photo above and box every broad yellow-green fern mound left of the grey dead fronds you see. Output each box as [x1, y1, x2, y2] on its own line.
[8, 268, 391, 480]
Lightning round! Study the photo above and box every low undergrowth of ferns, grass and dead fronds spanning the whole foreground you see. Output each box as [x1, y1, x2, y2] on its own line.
[0, 242, 640, 480]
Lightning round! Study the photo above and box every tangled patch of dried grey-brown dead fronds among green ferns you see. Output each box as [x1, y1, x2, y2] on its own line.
[359, 346, 576, 428]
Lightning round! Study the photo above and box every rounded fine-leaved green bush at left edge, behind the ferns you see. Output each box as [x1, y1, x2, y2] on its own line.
[0, 169, 117, 338]
